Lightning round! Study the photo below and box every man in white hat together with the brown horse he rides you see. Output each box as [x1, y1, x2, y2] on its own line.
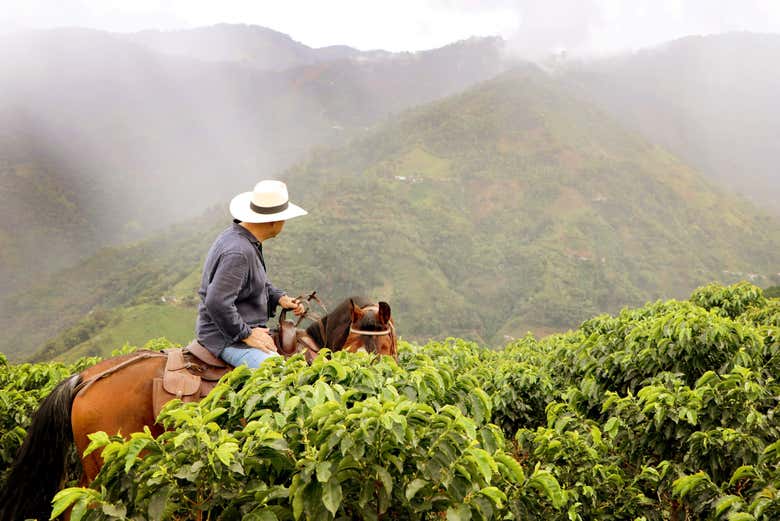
[0, 181, 398, 521]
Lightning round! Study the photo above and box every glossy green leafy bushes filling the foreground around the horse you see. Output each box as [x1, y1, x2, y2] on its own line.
[0, 283, 780, 520]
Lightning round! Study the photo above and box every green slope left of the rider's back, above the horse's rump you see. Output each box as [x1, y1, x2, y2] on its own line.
[0, 212, 220, 358]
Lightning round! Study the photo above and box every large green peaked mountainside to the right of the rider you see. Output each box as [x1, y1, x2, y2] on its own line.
[272, 66, 780, 342]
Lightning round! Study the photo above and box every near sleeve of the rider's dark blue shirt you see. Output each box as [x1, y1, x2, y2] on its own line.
[204, 252, 251, 342]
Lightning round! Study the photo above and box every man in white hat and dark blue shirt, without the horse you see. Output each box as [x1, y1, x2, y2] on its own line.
[195, 180, 308, 368]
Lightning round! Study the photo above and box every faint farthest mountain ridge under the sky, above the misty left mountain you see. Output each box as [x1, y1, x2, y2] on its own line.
[124, 24, 393, 70]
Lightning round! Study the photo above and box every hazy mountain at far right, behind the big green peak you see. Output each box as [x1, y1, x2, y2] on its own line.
[564, 33, 780, 215]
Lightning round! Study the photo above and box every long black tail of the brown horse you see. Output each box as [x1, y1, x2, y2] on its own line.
[0, 375, 81, 521]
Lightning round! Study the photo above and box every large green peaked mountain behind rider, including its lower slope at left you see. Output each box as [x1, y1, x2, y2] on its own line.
[7, 66, 780, 362]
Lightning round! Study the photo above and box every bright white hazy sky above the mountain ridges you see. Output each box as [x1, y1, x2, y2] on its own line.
[0, 0, 780, 53]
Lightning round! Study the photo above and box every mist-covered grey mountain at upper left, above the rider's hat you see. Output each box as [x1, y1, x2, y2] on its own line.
[0, 27, 503, 292]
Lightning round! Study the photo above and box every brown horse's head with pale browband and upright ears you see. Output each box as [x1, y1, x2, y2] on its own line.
[343, 300, 398, 360]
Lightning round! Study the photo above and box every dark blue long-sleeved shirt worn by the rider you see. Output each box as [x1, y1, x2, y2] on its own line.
[195, 223, 284, 356]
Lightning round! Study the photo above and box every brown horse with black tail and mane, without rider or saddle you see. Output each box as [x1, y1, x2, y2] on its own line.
[0, 297, 398, 521]
